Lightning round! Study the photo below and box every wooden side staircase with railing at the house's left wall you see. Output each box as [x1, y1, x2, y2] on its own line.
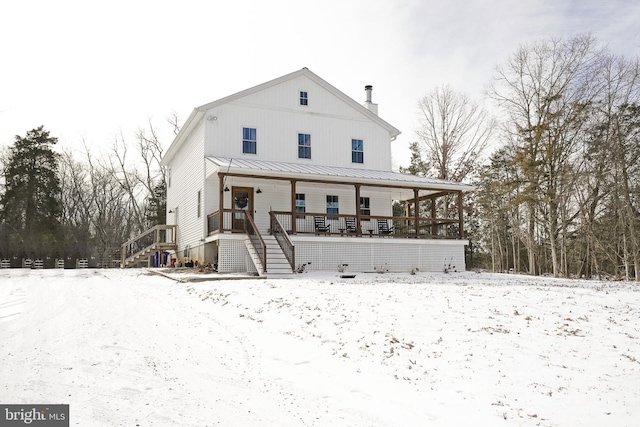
[120, 224, 176, 268]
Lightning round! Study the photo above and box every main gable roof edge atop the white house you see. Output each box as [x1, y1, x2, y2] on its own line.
[162, 67, 400, 166]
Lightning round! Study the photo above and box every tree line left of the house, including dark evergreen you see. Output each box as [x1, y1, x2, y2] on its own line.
[0, 124, 170, 266]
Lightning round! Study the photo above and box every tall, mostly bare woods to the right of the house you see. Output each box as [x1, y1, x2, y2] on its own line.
[405, 35, 640, 280]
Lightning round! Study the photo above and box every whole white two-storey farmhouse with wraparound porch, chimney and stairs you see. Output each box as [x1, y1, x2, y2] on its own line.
[123, 68, 472, 276]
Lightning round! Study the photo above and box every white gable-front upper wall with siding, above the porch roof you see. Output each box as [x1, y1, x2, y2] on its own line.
[205, 76, 391, 170]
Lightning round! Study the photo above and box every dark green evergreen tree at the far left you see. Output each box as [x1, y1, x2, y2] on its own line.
[0, 126, 62, 254]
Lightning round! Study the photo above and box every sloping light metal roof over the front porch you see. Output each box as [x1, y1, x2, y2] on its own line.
[206, 157, 474, 192]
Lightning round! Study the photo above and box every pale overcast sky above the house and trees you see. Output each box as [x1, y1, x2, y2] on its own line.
[0, 0, 640, 166]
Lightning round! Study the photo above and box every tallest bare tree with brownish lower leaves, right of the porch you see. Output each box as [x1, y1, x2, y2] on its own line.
[489, 35, 604, 276]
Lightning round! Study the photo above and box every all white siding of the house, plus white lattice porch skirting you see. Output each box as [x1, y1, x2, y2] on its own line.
[159, 67, 466, 272]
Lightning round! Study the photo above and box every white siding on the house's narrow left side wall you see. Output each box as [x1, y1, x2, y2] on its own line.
[167, 121, 207, 251]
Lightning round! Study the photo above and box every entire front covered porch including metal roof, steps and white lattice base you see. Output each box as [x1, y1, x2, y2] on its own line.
[204, 158, 472, 275]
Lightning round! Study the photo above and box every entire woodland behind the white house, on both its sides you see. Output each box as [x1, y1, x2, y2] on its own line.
[0, 34, 640, 280]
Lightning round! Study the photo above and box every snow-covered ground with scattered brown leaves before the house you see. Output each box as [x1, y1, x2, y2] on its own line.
[0, 270, 640, 427]
